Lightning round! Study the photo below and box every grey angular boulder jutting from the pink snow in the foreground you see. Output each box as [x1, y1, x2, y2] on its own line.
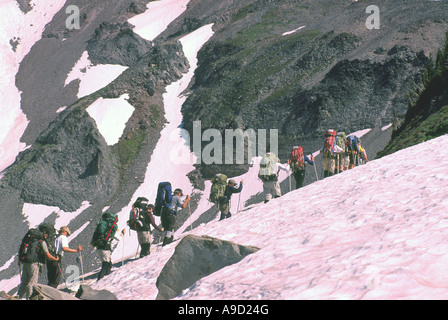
[156, 235, 259, 300]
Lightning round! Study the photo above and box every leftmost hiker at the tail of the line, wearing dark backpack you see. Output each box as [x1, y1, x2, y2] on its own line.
[18, 225, 59, 300]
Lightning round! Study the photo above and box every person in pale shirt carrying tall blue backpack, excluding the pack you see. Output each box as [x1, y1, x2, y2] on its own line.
[160, 189, 190, 246]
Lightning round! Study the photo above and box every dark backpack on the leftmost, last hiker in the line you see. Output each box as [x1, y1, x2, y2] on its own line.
[19, 228, 45, 263]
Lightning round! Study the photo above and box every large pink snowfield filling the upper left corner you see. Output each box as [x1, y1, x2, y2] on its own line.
[0, 0, 65, 172]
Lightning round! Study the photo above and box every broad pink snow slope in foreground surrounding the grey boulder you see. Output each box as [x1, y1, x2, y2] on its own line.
[94, 135, 448, 300]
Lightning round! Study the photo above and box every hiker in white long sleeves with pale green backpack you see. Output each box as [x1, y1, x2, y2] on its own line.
[258, 152, 289, 203]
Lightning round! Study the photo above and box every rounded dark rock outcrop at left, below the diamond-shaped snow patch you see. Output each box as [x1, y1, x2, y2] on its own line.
[2, 109, 119, 212]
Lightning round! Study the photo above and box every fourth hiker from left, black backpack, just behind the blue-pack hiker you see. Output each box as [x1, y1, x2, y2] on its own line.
[128, 197, 165, 258]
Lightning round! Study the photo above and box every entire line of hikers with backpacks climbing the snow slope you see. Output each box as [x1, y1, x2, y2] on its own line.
[18, 130, 369, 299]
